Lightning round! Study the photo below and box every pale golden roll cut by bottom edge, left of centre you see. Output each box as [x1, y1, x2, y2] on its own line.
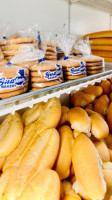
[17, 169, 60, 200]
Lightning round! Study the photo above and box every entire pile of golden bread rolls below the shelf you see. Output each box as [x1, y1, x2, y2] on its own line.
[0, 79, 112, 200]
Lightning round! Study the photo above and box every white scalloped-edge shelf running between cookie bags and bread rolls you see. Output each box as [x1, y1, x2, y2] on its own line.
[0, 67, 112, 116]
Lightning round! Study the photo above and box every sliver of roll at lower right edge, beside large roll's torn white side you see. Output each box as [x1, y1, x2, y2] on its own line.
[103, 162, 112, 187]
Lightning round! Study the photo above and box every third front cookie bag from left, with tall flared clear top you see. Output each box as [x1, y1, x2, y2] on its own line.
[57, 34, 86, 81]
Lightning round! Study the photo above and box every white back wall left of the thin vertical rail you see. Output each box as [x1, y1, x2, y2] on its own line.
[0, 0, 68, 31]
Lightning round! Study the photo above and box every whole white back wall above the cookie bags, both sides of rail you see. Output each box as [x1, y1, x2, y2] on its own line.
[0, 0, 110, 35]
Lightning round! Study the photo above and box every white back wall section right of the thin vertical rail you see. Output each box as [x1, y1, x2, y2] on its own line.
[71, 4, 110, 35]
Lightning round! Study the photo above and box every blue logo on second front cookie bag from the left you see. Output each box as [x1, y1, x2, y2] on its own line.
[44, 64, 63, 81]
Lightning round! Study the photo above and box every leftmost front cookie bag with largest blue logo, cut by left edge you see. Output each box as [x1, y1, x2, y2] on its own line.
[0, 65, 29, 94]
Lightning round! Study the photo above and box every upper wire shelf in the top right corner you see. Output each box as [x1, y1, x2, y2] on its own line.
[65, 0, 112, 14]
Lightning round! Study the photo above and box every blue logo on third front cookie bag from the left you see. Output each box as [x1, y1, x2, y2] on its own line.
[70, 61, 86, 75]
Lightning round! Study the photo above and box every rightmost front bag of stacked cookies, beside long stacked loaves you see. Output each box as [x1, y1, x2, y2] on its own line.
[75, 38, 105, 75]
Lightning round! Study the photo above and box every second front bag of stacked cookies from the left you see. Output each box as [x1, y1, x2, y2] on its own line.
[30, 50, 63, 90]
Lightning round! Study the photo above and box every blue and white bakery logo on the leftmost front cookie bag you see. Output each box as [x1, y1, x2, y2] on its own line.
[0, 69, 28, 89]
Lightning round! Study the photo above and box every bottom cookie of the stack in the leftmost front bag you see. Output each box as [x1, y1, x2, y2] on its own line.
[0, 85, 28, 100]
